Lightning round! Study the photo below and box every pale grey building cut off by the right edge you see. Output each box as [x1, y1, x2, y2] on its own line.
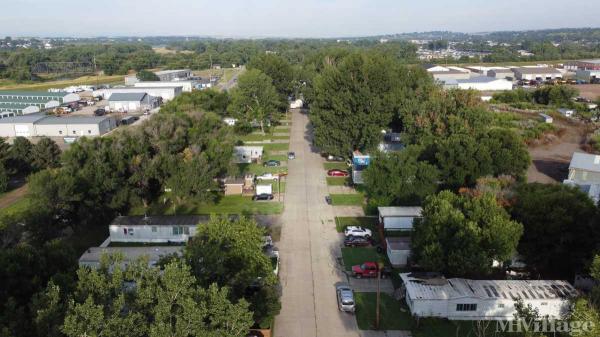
[563, 152, 600, 203]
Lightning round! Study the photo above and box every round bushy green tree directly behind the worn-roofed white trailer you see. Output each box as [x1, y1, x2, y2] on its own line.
[412, 191, 523, 277]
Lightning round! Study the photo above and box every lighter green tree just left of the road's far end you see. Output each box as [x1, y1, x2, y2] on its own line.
[229, 69, 281, 132]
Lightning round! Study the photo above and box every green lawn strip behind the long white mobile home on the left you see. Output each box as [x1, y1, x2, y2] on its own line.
[129, 195, 283, 215]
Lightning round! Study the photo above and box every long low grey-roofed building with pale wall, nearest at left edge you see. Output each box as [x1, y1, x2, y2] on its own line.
[0, 114, 117, 137]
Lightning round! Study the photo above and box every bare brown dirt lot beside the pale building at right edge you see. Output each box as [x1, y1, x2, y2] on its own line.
[527, 118, 588, 183]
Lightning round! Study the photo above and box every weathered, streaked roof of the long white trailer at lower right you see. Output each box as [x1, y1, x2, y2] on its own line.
[400, 273, 577, 300]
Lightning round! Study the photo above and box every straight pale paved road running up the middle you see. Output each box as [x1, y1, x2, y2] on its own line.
[275, 111, 359, 337]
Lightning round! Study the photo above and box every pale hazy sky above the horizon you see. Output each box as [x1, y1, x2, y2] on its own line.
[0, 0, 600, 37]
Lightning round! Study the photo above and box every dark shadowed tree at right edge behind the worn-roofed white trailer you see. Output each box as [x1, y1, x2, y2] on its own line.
[510, 183, 600, 279]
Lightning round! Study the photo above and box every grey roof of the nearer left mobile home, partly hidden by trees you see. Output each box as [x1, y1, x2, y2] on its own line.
[79, 246, 183, 268]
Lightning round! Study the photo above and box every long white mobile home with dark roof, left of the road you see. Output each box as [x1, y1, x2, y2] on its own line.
[108, 215, 210, 243]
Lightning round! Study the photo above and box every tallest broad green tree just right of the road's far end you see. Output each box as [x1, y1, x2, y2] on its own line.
[310, 53, 406, 155]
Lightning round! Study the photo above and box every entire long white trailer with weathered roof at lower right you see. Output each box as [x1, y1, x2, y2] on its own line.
[400, 273, 577, 321]
